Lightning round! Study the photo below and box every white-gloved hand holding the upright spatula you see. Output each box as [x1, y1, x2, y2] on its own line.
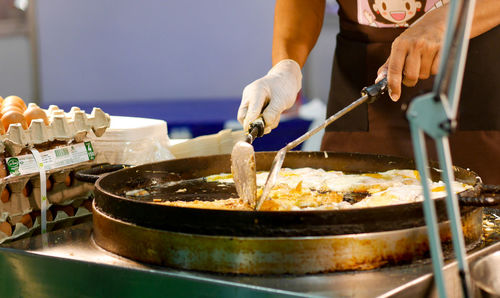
[238, 59, 302, 134]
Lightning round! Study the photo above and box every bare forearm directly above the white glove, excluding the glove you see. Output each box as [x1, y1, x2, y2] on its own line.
[272, 0, 325, 67]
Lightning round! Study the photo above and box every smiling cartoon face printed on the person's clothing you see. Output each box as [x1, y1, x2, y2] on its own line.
[369, 0, 425, 27]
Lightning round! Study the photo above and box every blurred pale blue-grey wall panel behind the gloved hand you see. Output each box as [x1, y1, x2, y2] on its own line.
[37, 0, 274, 104]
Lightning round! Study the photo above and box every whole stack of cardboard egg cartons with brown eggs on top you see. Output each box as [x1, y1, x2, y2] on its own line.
[0, 96, 110, 238]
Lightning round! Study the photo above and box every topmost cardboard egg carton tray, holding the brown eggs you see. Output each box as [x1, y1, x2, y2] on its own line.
[0, 103, 110, 156]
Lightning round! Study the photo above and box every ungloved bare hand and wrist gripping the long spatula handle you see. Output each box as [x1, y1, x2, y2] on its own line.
[378, 0, 500, 101]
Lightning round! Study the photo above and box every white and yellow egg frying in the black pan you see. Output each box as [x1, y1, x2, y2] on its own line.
[207, 168, 472, 210]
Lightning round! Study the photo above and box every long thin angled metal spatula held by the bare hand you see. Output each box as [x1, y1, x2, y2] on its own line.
[255, 78, 387, 210]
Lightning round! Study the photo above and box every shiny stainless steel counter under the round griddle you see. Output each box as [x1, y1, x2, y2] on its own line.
[0, 218, 500, 297]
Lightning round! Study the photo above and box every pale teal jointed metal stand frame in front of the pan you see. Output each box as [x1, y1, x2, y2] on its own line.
[407, 0, 475, 297]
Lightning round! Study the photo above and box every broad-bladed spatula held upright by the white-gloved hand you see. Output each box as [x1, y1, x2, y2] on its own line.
[231, 117, 265, 207]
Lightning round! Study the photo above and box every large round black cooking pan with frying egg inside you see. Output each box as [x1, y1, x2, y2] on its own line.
[89, 152, 496, 237]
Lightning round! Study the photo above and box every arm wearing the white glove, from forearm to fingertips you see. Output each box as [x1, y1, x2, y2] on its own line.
[237, 0, 325, 133]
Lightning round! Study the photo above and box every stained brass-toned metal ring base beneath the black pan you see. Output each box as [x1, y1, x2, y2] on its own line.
[93, 203, 482, 274]
